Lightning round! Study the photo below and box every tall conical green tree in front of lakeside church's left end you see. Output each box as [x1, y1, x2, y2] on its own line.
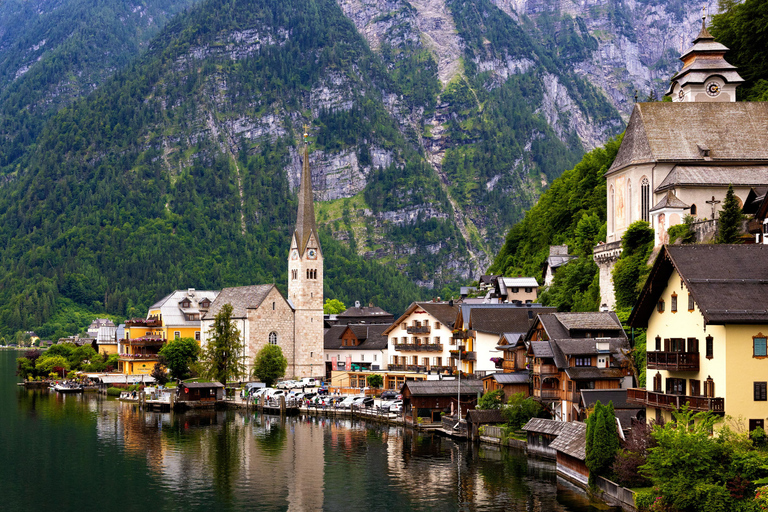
[201, 304, 245, 386]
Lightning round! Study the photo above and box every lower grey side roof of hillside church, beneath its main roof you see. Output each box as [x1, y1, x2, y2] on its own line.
[656, 165, 768, 192]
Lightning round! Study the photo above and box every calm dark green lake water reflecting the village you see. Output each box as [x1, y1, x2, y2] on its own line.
[0, 350, 619, 512]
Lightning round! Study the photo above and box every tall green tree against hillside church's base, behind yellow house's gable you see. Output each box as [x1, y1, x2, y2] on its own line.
[613, 220, 654, 309]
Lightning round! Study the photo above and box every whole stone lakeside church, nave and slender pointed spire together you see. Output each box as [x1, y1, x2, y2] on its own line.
[201, 133, 325, 377]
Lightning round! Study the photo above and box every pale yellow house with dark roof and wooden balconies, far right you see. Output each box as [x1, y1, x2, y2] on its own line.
[628, 244, 768, 430]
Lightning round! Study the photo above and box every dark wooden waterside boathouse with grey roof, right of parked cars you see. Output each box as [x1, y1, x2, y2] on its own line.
[401, 379, 483, 424]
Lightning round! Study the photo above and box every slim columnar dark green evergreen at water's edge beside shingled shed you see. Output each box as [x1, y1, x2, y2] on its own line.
[585, 400, 619, 485]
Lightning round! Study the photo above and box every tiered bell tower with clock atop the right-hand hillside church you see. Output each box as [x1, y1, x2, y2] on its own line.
[667, 8, 744, 102]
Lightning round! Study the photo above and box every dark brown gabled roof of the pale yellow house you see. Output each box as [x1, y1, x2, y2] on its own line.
[629, 244, 768, 327]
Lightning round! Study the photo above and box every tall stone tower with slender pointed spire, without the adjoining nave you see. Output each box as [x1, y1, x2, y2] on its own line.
[286, 127, 325, 377]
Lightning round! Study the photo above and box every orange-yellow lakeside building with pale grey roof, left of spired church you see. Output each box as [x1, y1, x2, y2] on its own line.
[118, 288, 219, 375]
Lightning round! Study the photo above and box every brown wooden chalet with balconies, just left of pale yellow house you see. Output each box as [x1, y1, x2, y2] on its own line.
[526, 312, 633, 421]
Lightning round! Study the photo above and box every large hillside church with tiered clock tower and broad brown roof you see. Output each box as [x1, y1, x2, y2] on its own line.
[594, 18, 768, 308]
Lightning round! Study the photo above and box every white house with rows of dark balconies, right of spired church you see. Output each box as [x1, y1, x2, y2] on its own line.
[382, 301, 460, 373]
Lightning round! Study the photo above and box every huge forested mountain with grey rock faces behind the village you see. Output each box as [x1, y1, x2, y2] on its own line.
[0, 0, 720, 332]
